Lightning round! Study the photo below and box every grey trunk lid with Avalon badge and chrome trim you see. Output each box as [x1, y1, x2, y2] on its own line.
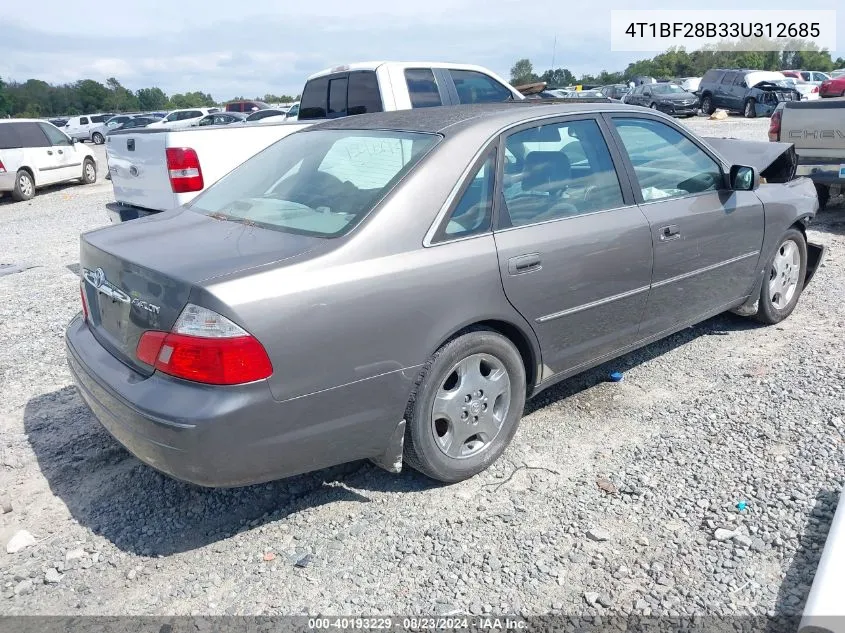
[80, 209, 325, 375]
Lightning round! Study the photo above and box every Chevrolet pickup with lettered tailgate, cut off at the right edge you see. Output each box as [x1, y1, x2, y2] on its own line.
[769, 98, 845, 209]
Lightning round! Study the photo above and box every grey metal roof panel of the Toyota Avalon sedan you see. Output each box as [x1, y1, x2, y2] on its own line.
[312, 99, 643, 136]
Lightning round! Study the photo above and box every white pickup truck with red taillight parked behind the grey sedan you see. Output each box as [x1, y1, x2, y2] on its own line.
[106, 62, 525, 222]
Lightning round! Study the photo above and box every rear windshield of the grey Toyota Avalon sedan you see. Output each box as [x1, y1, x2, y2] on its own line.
[187, 130, 440, 237]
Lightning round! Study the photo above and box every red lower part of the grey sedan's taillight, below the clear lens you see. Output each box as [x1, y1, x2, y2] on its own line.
[136, 331, 273, 385]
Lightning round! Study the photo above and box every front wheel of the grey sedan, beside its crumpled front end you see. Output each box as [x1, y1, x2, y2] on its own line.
[754, 229, 807, 325]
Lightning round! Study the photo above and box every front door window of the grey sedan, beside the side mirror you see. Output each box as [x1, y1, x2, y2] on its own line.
[613, 118, 723, 200]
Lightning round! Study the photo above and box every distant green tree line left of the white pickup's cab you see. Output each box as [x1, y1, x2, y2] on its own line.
[0, 77, 298, 118]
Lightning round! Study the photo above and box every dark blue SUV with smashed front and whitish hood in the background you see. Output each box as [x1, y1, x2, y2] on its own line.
[698, 68, 801, 119]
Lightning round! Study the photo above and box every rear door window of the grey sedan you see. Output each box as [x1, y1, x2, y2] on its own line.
[503, 119, 624, 226]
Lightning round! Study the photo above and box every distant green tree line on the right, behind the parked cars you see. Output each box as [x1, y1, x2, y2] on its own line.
[510, 42, 845, 88]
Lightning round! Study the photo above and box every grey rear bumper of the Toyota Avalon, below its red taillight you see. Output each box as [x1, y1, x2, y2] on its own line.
[65, 316, 406, 487]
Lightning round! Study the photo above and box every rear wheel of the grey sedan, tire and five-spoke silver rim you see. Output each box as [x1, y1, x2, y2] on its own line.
[404, 328, 526, 483]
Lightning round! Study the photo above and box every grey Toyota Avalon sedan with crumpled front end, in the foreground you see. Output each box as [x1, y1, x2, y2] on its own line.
[66, 102, 823, 486]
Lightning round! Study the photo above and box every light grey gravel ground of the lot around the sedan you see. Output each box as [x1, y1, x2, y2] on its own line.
[0, 118, 845, 615]
